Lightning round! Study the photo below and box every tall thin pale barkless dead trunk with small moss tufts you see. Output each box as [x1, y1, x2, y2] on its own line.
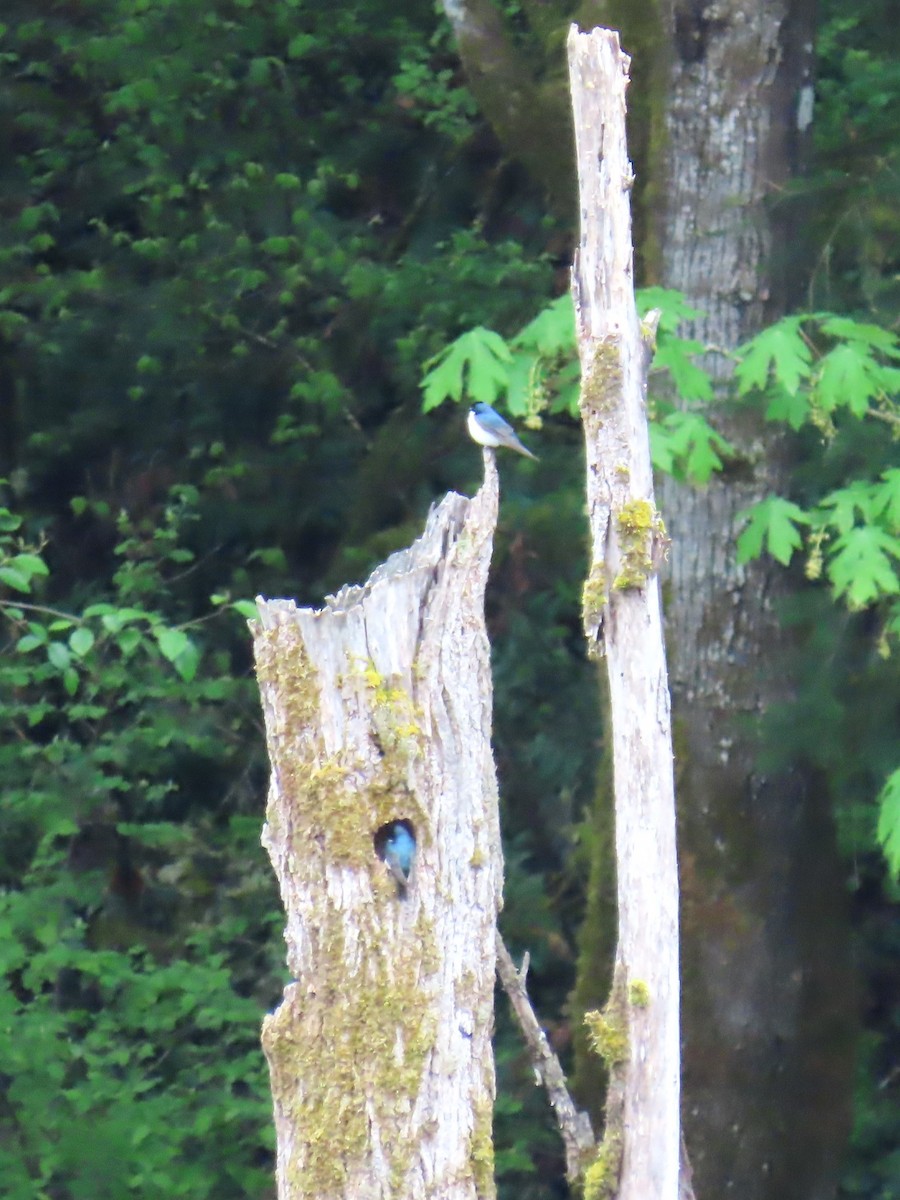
[569, 26, 690, 1200]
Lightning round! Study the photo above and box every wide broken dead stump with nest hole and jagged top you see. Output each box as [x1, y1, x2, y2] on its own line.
[251, 452, 502, 1200]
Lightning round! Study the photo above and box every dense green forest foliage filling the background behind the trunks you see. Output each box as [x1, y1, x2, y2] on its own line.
[0, 0, 900, 1200]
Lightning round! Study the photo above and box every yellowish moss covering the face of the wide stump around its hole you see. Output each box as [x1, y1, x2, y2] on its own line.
[257, 624, 440, 1200]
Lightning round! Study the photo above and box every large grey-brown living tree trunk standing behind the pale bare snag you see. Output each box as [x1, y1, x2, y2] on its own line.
[662, 0, 853, 1200]
